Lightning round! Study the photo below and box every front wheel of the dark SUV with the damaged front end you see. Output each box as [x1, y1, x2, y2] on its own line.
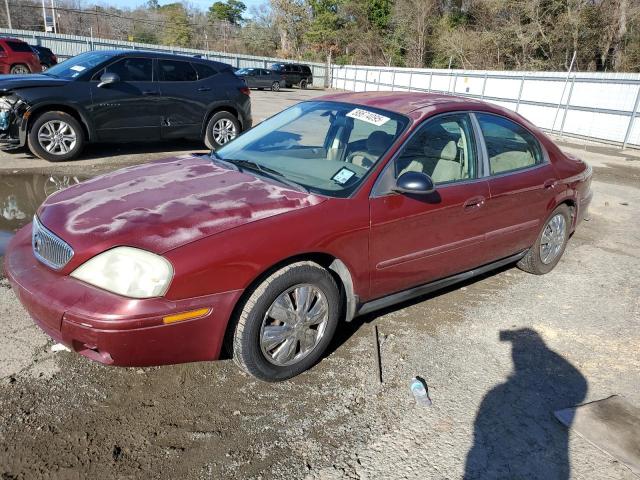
[27, 112, 85, 162]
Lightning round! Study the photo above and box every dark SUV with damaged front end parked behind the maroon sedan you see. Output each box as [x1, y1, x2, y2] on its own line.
[0, 51, 252, 161]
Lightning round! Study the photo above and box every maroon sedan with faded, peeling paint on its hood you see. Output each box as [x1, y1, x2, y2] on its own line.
[5, 92, 591, 381]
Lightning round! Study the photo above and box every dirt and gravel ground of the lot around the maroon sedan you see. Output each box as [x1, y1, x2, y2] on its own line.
[0, 91, 640, 479]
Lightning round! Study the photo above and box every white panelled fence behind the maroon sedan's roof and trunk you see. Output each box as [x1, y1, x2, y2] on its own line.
[332, 65, 640, 148]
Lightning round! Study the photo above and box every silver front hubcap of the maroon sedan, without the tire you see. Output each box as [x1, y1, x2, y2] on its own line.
[260, 284, 329, 366]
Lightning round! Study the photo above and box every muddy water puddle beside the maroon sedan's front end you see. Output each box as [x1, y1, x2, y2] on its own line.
[0, 174, 86, 256]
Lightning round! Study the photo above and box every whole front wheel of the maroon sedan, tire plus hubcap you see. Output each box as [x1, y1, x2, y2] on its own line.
[229, 262, 341, 382]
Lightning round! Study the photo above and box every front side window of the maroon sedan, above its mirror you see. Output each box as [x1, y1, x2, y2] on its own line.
[395, 113, 477, 184]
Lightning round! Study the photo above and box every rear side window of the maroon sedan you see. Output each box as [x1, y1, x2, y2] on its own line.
[476, 113, 543, 175]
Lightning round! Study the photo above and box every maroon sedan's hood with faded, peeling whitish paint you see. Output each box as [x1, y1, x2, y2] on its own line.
[38, 155, 325, 257]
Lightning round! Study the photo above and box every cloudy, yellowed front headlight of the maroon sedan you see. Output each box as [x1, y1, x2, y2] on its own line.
[71, 247, 173, 298]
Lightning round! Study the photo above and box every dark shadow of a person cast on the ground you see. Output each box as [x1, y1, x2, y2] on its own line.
[464, 328, 587, 480]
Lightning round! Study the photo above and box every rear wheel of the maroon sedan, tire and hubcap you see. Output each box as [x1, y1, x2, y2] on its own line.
[518, 204, 571, 275]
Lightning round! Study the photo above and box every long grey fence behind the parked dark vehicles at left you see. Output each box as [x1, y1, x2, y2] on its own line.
[0, 28, 327, 87]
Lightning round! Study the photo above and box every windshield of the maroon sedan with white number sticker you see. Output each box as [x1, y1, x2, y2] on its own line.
[215, 101, 408, 197]
